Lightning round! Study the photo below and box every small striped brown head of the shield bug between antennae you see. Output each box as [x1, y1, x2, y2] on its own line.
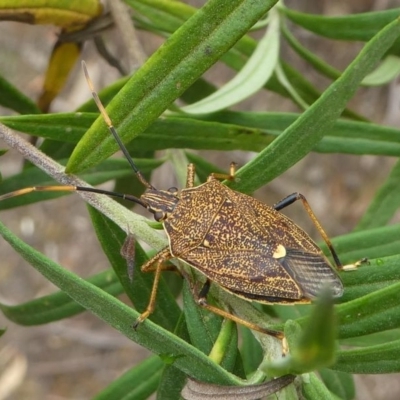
[140, 187, 179, 221]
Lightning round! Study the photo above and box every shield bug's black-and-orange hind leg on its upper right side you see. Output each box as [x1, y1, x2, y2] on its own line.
[274, 192, 367, 271]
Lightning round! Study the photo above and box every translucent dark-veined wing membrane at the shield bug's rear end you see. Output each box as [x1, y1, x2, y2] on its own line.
[278, 249, 343, 298]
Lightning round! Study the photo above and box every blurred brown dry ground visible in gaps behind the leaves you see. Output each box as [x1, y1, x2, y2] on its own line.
[0, 0, 400, 400]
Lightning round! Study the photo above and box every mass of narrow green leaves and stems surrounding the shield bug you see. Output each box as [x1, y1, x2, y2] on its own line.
[0, 0, 400, 400]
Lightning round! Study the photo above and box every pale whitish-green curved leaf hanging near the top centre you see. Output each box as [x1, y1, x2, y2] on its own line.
[181, 11, 279, 114]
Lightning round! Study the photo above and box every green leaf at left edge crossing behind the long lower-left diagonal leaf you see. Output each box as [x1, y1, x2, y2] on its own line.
[0, 270, 123, 326]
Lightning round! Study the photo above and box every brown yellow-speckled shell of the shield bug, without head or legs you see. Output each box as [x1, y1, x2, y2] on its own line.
[159, 179, 343, 303]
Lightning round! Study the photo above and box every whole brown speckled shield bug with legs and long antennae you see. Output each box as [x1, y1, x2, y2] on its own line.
[0, 65, 356, 339]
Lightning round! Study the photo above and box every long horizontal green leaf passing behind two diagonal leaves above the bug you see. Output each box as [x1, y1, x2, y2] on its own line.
[0, 112, 400, 157]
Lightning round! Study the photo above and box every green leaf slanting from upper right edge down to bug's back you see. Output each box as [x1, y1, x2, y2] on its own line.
[230, 16, 400, 193]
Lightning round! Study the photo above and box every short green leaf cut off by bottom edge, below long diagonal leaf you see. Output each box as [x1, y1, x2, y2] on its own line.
[93, 356, 164, 400]
